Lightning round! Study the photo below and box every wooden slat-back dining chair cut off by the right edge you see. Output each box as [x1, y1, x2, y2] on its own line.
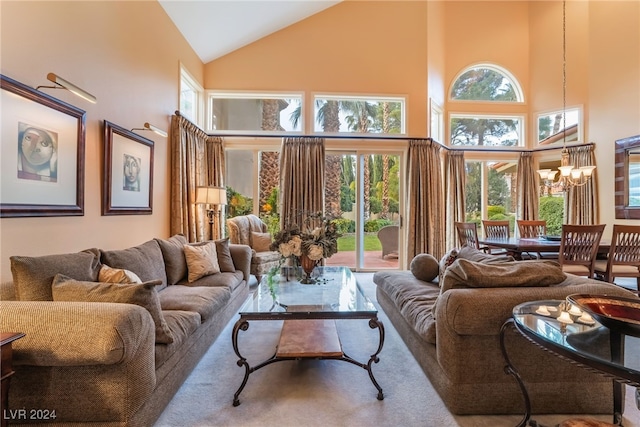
[594, 224, 640, 293]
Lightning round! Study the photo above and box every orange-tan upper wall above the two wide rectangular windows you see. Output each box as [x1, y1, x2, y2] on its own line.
[204, 1, 428, 137]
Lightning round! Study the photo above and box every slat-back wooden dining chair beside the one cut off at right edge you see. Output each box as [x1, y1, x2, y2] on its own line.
[558, 224, 605, 278]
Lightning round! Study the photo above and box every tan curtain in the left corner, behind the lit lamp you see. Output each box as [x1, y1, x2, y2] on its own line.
[169, 114, 225, 242]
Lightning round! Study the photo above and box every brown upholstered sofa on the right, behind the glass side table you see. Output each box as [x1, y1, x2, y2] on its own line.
[373, 248, 634, 415]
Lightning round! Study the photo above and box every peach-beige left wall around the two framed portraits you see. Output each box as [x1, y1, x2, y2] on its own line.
[0, 1, 203, 281]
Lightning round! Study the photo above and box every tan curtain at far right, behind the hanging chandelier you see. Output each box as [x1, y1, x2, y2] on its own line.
[564, 144, 598, 225]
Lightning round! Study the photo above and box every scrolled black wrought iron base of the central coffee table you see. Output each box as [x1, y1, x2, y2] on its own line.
[231, 318, 384, 406]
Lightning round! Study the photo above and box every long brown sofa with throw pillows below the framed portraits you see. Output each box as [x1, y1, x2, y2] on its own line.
[0, 235, 251, 427]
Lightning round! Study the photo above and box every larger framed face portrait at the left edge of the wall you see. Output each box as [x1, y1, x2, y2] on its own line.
[0, 75, 86, 218]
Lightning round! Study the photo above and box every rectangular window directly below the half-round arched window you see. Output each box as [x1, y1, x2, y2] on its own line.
[450, 114, 524, 147]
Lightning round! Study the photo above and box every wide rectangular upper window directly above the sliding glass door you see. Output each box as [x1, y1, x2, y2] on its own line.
[314, 95, 406, 135]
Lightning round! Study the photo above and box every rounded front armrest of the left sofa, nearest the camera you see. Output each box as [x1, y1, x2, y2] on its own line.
[0, 301, 155, 367]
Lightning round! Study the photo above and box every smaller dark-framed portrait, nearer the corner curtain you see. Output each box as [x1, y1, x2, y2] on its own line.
[102, 120, 153, 215]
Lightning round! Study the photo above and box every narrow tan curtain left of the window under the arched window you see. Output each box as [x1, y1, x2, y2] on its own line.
[444, 150, 466, 249]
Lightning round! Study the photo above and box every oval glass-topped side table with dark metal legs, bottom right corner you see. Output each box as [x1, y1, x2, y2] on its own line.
[500, 300, 640, 427]
